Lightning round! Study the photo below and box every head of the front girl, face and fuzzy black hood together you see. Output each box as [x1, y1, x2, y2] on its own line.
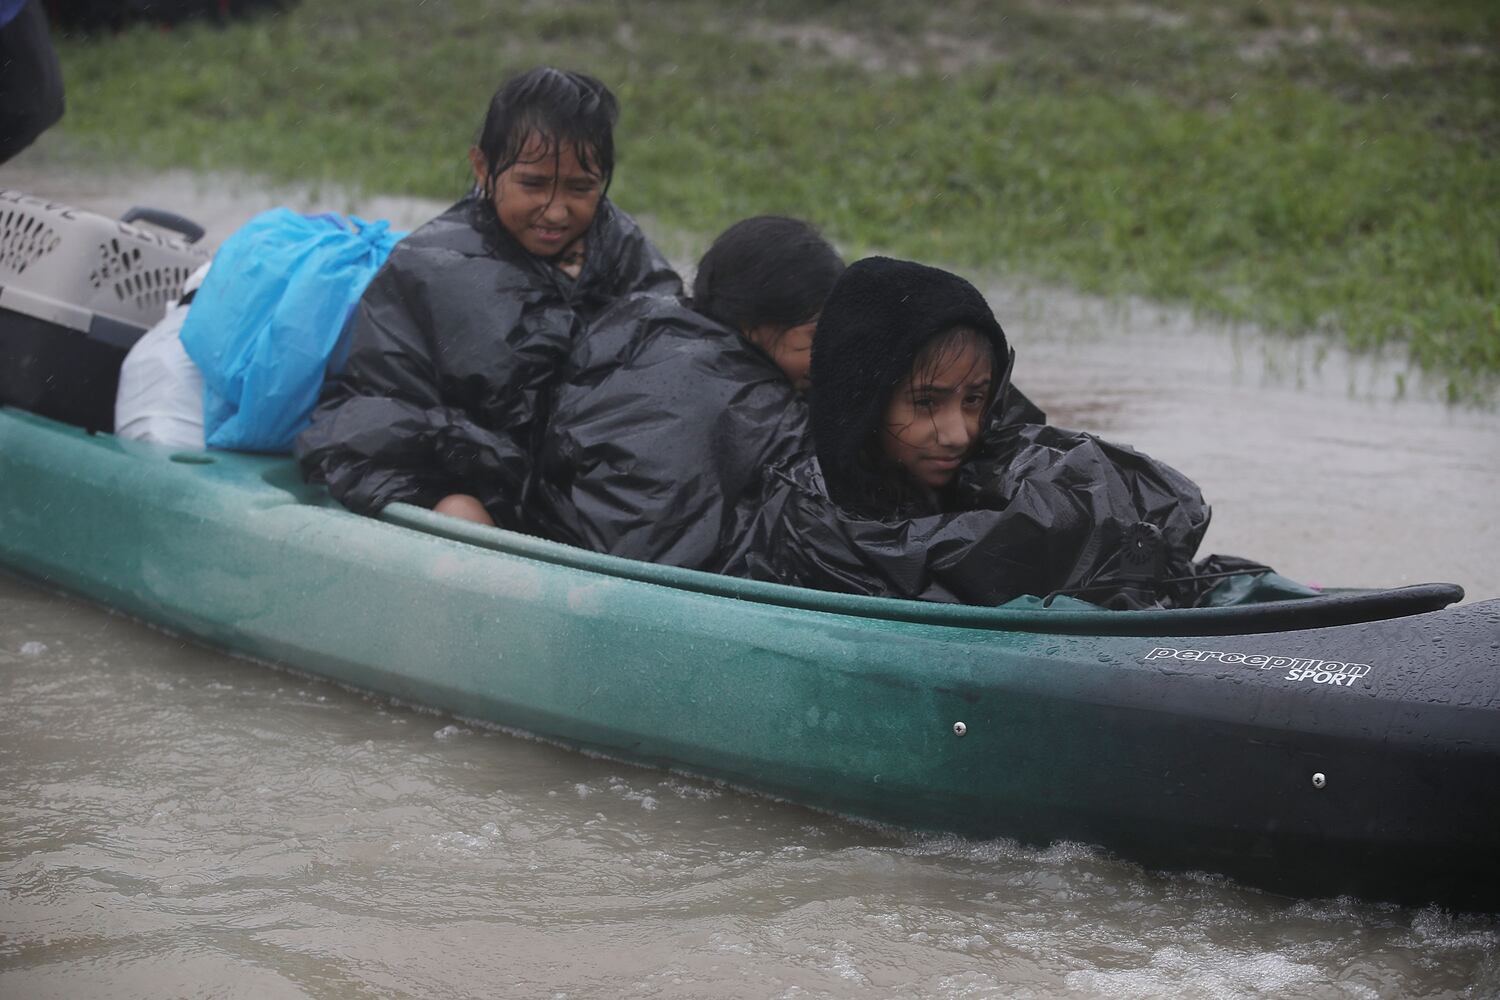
[809, 256, 1013, 517]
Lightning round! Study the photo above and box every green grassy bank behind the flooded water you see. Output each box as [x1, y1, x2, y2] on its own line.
[46, 0, 1500, 397]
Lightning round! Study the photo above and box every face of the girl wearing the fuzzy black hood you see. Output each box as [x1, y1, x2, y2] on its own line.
[881, 334, 992, 489]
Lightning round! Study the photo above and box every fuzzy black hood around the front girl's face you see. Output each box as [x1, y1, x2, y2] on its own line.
[807, 256, 1010, 517]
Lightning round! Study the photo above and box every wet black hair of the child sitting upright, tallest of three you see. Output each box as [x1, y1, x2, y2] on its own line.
[474, 66, 620, 192]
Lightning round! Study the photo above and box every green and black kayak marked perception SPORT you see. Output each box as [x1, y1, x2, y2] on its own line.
[0, 408, 1500, 910]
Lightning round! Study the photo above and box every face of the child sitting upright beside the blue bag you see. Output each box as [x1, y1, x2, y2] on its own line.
[470, 133, 605, 258]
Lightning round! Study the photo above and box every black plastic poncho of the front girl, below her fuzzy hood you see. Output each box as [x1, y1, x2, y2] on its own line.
[716, 424, 1212, 609]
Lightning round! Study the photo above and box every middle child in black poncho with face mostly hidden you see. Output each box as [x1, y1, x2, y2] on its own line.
[531, 216, 845, 568]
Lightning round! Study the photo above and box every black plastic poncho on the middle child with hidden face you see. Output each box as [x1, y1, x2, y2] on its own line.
[528, 294, 807, 568]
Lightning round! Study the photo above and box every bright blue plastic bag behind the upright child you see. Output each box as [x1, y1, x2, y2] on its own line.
[182, 208, 405, 451]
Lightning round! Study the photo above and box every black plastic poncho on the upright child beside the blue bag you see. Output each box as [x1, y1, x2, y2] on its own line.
[296, 195, 683, 528]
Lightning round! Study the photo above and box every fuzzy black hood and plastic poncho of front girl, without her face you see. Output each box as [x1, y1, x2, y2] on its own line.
[716, 258, 1209, 607]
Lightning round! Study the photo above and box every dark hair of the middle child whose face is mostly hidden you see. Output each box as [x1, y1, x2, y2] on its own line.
[693, 216, 845, 333]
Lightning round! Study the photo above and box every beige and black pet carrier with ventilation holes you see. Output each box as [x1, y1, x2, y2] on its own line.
[0, 190, 210, 430]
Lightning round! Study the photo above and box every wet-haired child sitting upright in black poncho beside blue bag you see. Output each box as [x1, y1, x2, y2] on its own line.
[296, 67, 681, 528]
